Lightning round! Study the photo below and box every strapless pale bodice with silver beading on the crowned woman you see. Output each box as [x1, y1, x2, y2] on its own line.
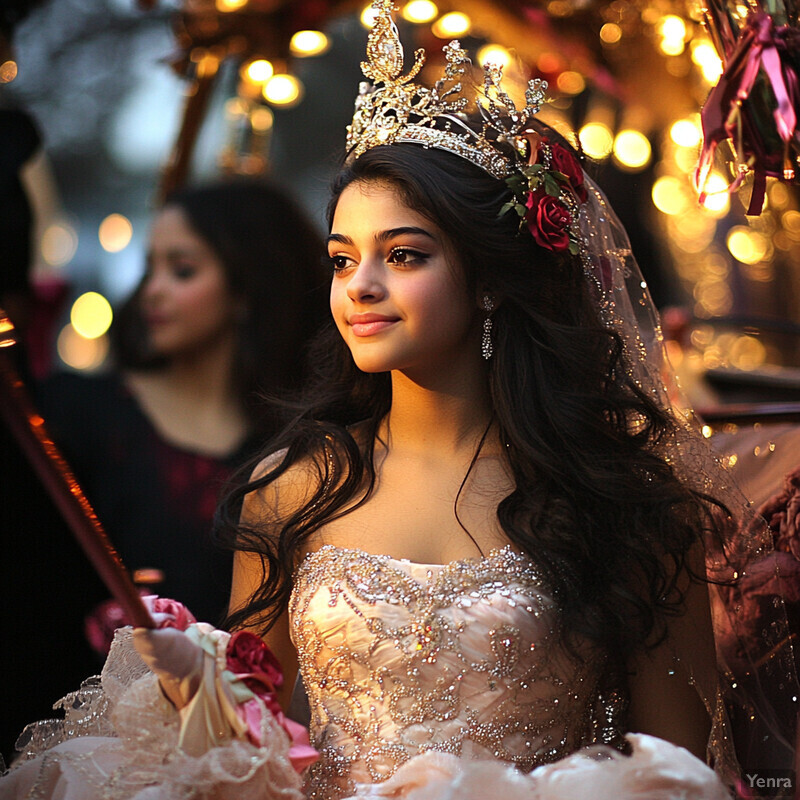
[290, 545, 623, 800]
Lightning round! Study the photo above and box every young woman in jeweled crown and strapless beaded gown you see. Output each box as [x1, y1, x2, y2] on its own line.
[4, 7, 792, 800]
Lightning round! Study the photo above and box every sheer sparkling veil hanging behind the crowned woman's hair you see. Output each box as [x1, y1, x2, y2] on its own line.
[577, 177, 800, 782]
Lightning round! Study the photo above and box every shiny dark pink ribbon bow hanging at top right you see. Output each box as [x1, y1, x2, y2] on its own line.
[696, 11, 800, 215]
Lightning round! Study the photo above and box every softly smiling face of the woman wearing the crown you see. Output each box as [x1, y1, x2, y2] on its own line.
[328, 183, 479, 373]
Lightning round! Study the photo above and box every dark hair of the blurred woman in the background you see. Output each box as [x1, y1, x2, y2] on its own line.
[111, 178, 328, 433]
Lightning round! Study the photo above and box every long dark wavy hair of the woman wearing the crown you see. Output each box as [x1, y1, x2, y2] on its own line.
[218, 144, 712, 661]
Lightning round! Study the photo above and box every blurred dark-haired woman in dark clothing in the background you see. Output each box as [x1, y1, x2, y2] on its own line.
[34, 181, 325, 622]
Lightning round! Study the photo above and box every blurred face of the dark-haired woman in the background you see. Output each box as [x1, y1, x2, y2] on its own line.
[140, 206, 239, 357]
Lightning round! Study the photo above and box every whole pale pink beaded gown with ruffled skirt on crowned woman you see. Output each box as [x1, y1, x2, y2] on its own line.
[0, 546, 729, 800]
